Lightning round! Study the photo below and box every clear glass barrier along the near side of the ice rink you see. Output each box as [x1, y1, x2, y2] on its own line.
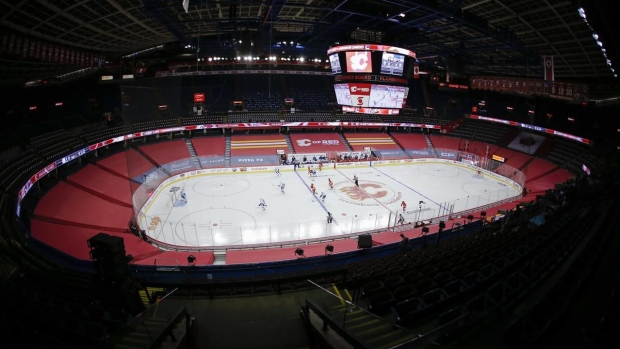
[140, 181, 520, 249]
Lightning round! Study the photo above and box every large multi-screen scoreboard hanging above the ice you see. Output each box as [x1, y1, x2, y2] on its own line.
[327, 44, 415, 115]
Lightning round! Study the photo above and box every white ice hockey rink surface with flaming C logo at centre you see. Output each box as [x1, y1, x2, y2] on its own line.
[138, 162, 521, 248]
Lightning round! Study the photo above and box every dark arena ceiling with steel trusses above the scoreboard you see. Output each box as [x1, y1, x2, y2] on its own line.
[0, 0, 620, 91]
